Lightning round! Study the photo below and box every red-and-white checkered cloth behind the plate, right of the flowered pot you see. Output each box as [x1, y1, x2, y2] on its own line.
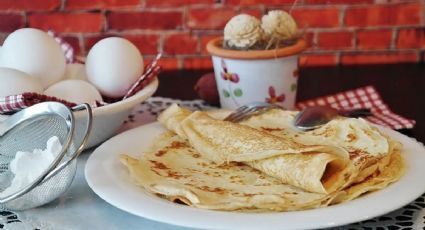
[295, 86, 416, 129]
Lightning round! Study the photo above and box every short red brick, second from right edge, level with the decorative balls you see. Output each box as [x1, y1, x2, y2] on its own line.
[357, 30, 392, 49]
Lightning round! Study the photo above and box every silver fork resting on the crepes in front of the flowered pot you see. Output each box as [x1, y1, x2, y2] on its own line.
[224, 102, 283, 122]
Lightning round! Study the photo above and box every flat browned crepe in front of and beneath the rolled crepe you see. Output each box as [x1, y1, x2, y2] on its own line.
[120, 131, 404, 212]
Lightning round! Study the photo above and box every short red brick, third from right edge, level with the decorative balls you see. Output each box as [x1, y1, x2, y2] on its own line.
[318, 31, 353, 49]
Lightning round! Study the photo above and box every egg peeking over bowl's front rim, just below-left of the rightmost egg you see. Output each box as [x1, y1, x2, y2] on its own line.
[44, 79, 102, 105]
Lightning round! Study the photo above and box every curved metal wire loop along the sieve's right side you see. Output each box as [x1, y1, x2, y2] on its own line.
[43, 103, 93, 181]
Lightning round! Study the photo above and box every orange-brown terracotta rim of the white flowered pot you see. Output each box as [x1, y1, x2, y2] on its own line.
[207, 37, 307, 59]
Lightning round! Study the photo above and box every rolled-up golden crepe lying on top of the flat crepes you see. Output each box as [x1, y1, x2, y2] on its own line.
[158, 105, 352, 194]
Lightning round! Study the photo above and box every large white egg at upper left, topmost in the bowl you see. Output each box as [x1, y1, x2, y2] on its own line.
[0, 28, 65, 88]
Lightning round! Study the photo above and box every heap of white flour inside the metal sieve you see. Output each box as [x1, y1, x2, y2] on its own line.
[0, 136, 62, 197]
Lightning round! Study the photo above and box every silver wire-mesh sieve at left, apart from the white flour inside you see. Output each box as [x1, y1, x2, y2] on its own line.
[0, 104, 92, 210]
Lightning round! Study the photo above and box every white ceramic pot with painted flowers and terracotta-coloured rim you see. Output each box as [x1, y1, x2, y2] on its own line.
[207, 38, 306, 109]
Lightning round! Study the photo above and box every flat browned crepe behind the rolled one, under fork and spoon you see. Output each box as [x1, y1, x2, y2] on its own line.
[237, 109, 401, 182]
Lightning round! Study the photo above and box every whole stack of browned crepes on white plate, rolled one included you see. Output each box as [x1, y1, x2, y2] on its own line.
[121, 105, 405, 211]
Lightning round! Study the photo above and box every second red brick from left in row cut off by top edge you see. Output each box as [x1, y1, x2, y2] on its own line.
[65, 0, 141, 10]
